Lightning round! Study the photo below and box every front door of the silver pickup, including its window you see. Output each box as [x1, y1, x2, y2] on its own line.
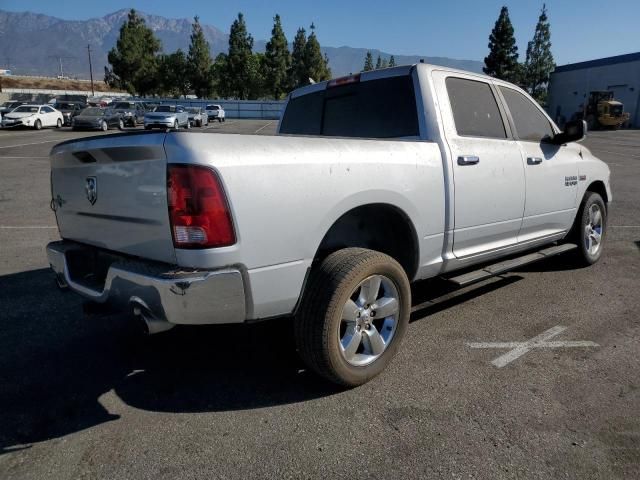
[498, 86, 578, 242]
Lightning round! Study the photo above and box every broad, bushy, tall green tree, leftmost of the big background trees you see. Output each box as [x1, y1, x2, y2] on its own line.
[105, 9, 161, 95]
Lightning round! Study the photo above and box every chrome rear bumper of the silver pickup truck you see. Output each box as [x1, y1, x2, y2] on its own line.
[47, 241, 246, 325]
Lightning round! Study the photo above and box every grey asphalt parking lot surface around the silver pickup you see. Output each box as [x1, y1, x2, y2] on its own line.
[0, 119, 640, 479]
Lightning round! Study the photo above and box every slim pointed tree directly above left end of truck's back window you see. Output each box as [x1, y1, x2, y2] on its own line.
[264, 14, 291, 100]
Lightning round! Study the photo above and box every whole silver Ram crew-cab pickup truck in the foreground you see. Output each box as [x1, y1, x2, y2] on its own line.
[48, 64, 612, 386]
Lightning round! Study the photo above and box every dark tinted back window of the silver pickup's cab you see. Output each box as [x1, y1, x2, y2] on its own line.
[280, 75, 419, 138]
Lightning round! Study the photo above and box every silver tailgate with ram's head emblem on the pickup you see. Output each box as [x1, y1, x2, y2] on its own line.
[51, 133, 175, 263]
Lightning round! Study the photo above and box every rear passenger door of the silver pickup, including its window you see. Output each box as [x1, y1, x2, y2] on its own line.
[433, 71, 525, 257]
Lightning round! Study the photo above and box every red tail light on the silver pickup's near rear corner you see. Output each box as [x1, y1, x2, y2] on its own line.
[167, 165, 236, 248]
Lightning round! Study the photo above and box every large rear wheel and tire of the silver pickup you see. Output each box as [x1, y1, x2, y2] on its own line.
[295, 248, 411, 387]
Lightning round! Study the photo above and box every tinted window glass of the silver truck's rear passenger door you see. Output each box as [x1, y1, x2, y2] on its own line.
[447, 77, 507, 138]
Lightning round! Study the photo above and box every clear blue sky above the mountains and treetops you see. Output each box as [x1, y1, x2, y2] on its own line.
[0, 0, 640, 65]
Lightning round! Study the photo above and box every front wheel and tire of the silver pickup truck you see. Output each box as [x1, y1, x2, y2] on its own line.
[571, 191, 607, 267]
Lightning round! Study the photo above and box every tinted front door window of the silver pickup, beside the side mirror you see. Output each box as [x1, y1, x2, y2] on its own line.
[500, 87, 554, 142]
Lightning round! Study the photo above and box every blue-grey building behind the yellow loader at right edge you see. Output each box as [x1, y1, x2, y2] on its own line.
[547, 52, 640, 128]
